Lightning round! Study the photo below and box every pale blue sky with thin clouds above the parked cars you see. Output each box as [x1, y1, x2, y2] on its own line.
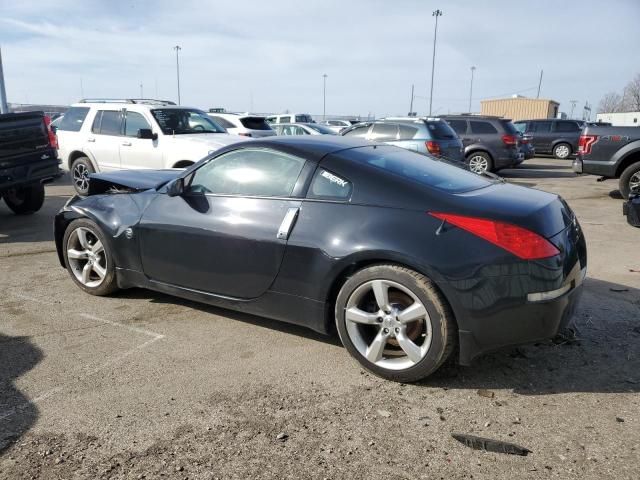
[0, 0, 640, 116]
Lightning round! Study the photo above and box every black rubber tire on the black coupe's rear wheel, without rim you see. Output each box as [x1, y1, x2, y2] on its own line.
[335, 264, 457, 382]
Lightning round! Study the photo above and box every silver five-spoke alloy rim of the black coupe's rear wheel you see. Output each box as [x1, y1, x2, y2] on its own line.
[345, 280, 432, 370]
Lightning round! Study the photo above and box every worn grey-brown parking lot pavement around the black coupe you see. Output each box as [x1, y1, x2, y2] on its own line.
[0, 158, 640, 479]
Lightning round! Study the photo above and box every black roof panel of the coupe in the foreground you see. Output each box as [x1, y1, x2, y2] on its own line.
[216, 136, 380, 162]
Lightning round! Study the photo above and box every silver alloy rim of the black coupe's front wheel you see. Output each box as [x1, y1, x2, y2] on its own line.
[67, 227, 107, 288]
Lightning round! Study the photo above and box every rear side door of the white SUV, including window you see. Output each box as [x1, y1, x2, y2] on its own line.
[87, 110, 123, 171]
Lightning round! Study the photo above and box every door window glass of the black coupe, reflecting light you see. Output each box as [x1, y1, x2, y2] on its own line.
[189, 148, 305, 197]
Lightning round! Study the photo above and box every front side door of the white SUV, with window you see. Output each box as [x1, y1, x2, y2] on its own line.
[119, 110, 164, 170]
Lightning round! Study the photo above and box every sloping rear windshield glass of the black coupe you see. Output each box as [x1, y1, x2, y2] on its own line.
[337, 145, 492, 193]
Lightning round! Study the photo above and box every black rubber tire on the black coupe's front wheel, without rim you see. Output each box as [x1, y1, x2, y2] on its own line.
[62, 218, 118, 296]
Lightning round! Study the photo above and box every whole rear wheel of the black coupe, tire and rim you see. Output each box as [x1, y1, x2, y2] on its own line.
[335, 265, 456, 382]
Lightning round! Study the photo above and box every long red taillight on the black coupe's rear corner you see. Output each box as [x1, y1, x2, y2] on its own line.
[429, 212, 560, 260]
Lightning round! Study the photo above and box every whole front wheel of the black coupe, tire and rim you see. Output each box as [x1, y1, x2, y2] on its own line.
[62, 219, 118, 295]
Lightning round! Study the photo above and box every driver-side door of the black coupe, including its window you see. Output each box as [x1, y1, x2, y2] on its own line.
[139, 147, 310, 299]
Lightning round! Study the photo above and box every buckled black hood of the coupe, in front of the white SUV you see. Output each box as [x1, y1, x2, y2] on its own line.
[88, 169, 183, 195]
